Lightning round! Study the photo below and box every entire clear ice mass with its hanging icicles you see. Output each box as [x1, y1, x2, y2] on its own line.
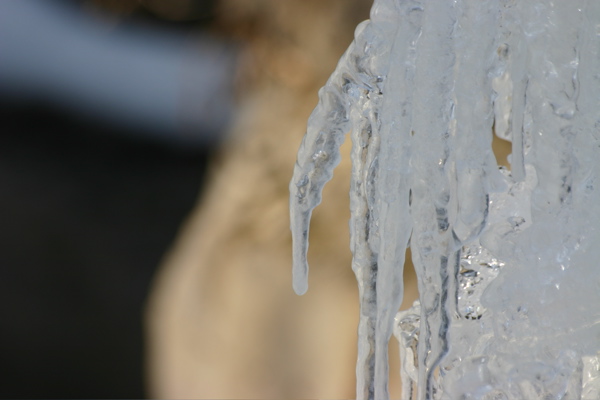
[290, 0, 600, 400]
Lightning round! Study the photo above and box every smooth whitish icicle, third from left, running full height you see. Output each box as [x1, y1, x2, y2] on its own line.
[374, 1, 423, 399]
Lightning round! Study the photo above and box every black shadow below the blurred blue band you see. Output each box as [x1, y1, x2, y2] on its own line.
[0, 104, 207, 398]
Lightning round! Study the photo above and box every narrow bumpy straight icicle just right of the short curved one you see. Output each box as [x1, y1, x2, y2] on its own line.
[350, 8, 395, 399]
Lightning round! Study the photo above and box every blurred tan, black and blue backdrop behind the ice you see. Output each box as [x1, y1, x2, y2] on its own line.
[0, 0, 416, 398]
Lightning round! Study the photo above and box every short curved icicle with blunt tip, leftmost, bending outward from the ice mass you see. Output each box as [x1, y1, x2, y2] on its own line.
[290, 0, 404, 294]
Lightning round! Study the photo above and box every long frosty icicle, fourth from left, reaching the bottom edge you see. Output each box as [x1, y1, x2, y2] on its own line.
[411, 0, 461, 398]
